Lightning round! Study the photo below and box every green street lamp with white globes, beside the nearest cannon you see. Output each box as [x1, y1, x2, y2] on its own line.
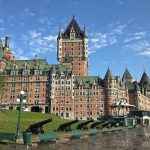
[16, 91, 26, 139]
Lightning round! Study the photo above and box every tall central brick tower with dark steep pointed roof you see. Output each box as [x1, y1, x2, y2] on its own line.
[57, 17, 88, 76]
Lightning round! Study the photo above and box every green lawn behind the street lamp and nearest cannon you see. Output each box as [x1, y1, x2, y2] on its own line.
[0, 111, 66, 133]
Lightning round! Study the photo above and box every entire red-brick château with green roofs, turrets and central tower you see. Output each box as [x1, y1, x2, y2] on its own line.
[0, 17, 150, 120]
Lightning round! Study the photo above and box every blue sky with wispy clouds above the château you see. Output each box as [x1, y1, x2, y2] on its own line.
[0, 0, 150, 79]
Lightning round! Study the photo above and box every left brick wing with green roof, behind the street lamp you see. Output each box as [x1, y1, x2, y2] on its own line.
[0, 59, 49, 111]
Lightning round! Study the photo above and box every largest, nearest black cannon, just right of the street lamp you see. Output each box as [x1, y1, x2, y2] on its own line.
[25, 118, 52, 134]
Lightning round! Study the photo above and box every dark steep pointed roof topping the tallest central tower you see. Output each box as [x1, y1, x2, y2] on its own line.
[59, 16, 86, 38]
